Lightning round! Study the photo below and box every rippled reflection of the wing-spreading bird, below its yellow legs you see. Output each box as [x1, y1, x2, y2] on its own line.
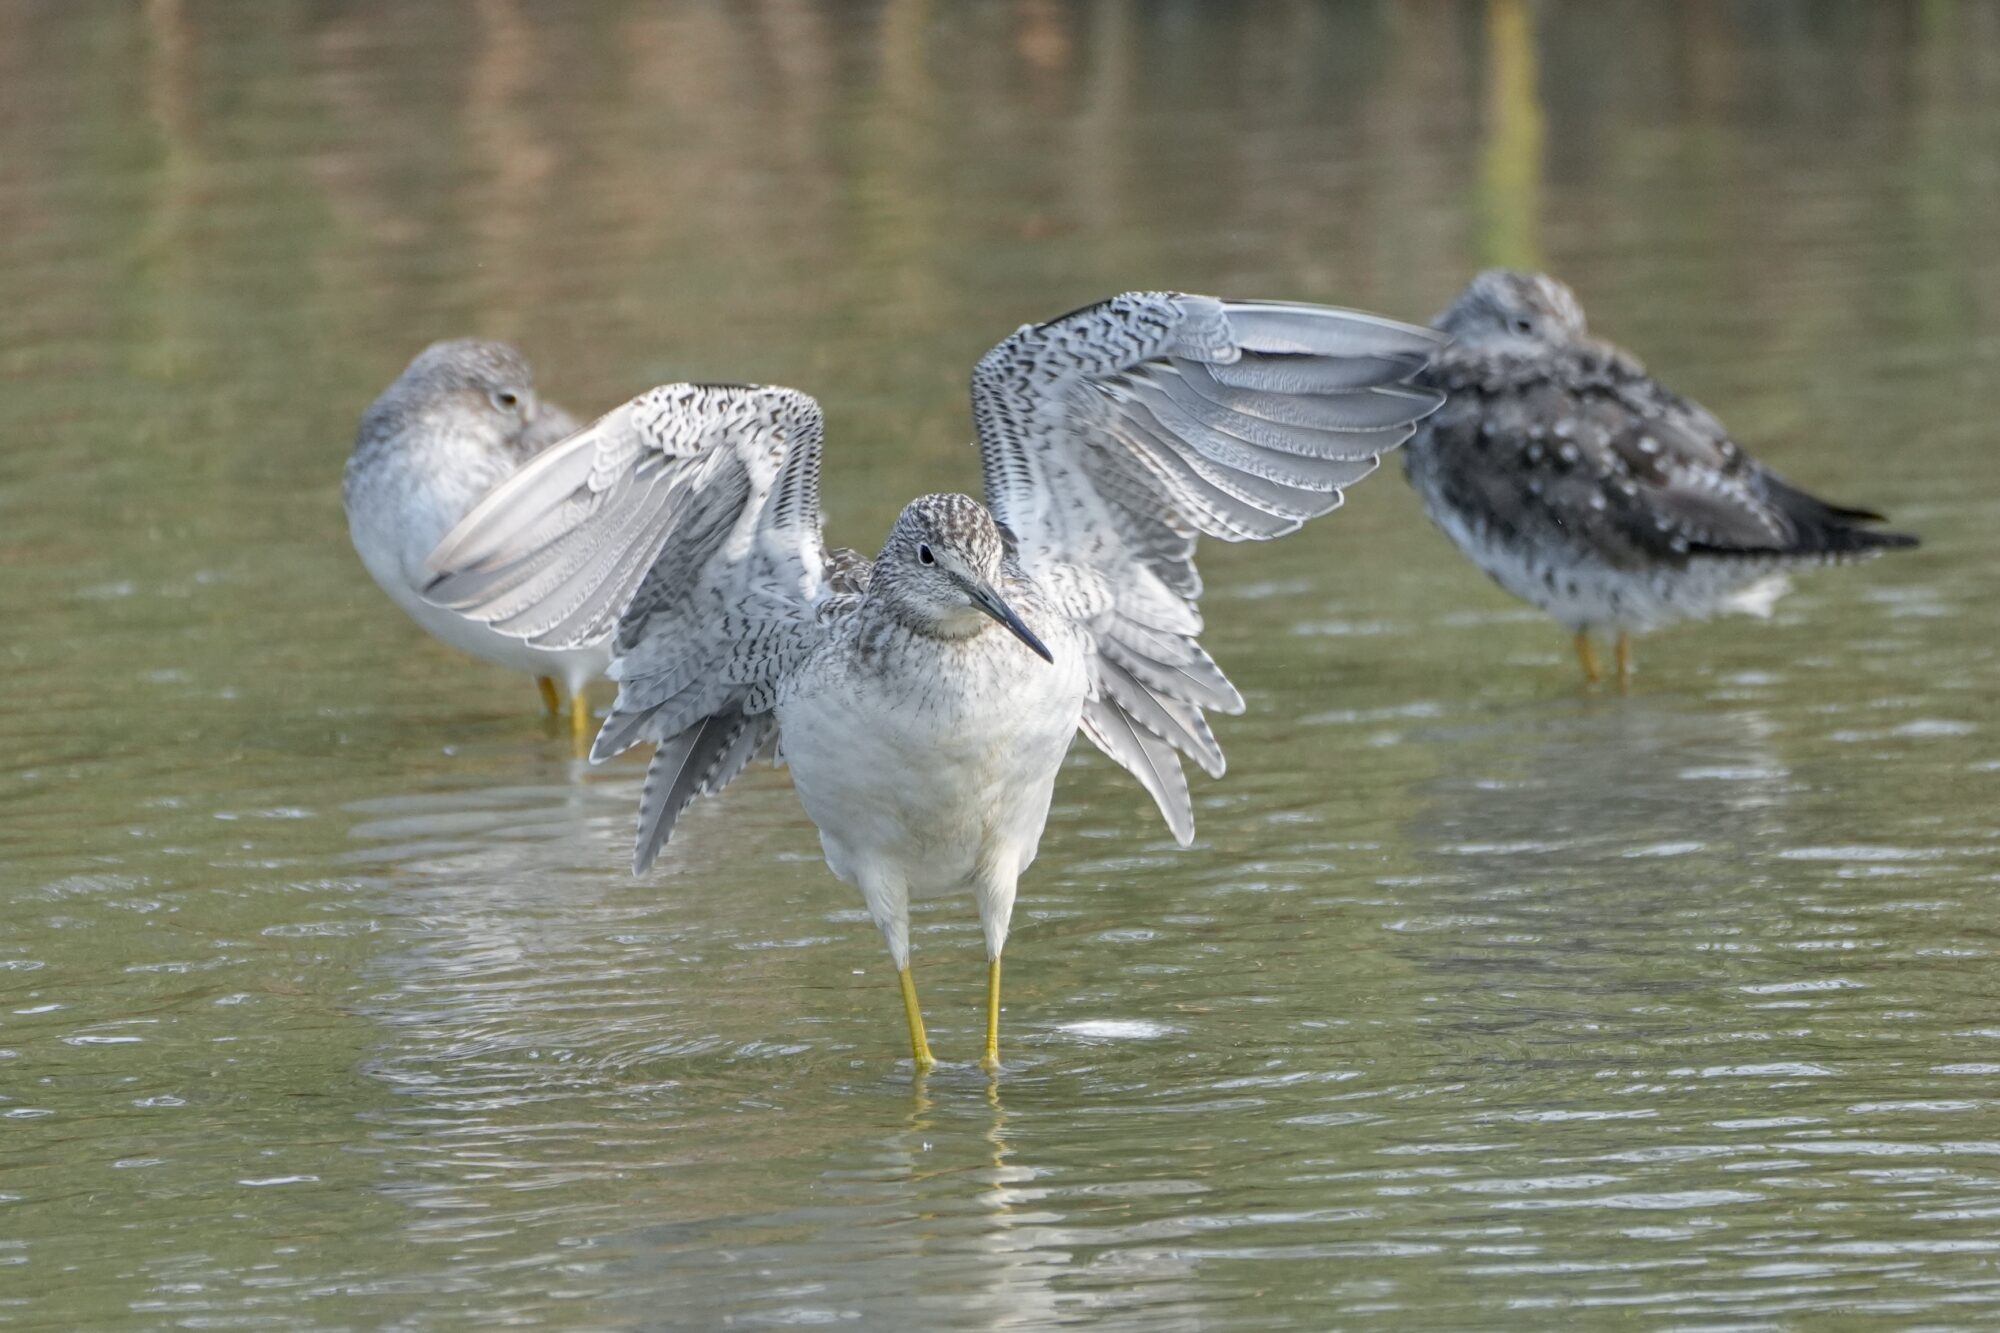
[580, 1067, 1196, 1329]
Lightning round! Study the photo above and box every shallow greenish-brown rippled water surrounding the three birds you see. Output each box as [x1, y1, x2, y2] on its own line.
[0, 0, 2000, 1329]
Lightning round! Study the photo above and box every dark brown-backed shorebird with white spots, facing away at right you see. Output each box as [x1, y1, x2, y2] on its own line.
[1402, 268, 1916, 687]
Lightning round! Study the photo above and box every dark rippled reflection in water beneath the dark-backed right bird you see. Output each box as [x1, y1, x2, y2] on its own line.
[1396, 697, 1798, 1055]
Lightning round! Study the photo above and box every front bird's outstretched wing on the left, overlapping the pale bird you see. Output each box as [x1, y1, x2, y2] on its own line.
[424, 384, 846, 873]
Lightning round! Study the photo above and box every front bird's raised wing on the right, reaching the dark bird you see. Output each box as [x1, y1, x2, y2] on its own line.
[972, 292, 1444, 845]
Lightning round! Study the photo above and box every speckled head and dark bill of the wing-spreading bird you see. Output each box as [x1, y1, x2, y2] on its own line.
[868, 494, 1054, 660]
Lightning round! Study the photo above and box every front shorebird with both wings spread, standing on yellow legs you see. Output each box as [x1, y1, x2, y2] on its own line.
[430, 292, 1440, 1069]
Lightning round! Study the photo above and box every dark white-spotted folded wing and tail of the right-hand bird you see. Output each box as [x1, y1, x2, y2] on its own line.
[1424, 344, 1914, 568]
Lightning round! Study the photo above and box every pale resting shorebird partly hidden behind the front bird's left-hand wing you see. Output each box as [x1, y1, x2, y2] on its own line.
[342, 338, 612, 741]
